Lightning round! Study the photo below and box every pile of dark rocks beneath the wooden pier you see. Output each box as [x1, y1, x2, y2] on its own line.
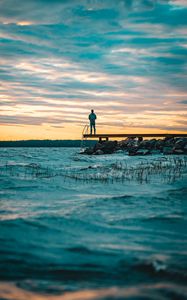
[81, 137, 187, 155]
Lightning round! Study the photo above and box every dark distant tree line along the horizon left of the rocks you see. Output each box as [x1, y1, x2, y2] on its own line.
[0, 140, 96, 147]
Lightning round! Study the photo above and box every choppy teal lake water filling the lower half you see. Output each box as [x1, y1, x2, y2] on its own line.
[0, 148, 187, 300]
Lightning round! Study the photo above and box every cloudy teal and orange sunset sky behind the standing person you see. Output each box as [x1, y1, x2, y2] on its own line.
[0, 0, 187, 140]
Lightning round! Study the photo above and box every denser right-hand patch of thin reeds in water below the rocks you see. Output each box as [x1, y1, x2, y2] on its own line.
[64, 157, 187, 183]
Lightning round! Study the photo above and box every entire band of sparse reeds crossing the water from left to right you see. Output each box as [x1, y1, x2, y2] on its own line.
[0, 156, 187, 183]
